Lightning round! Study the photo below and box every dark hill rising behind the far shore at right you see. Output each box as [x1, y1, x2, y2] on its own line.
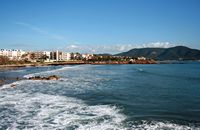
[116, 46, 200, 60]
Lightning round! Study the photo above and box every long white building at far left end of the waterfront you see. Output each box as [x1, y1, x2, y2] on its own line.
[0, 49, 25, 60]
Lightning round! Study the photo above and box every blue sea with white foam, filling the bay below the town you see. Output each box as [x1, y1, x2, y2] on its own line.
[0, 62, 200, 130]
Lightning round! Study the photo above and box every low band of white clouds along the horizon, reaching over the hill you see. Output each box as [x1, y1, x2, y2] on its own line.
[64, 42, 174, 54]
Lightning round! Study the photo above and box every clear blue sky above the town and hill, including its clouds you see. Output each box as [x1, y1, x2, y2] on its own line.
[0, 0, 200, 53]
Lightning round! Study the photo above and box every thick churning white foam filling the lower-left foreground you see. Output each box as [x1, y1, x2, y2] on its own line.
[0, 93, 126, 129]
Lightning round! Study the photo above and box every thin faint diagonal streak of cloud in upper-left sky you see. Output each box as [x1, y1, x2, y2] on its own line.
[15, 22, 64, 40]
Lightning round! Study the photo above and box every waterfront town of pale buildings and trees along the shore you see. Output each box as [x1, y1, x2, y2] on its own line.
[0, 49, 156, 65]
